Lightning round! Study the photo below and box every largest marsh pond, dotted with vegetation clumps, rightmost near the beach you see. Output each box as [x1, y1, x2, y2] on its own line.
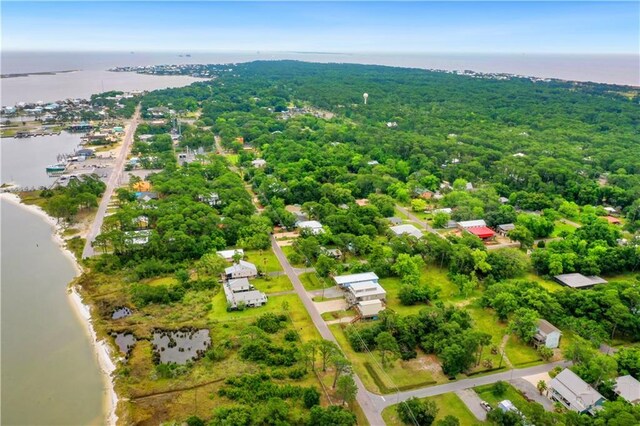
[152, 329, 211, 364]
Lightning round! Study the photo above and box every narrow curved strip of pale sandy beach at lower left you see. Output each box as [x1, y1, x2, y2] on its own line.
[0, 192, 118, 425]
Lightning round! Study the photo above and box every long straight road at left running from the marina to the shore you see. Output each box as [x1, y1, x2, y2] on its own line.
[82, 105, 140, 259]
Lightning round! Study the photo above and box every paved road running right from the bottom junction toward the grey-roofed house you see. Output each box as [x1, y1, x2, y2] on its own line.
[370, 361, 569, 412]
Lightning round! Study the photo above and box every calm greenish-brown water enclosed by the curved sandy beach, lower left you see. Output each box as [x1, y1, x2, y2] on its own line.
[0, 200, 104, 425]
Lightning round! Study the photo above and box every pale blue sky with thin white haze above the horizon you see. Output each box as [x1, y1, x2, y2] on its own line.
[1, 1, 640, 54]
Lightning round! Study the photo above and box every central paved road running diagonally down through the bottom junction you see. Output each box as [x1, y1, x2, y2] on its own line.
[271, 236, 384, 426]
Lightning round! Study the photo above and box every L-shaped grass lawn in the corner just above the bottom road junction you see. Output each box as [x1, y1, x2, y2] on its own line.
[329, 324, 447, 394]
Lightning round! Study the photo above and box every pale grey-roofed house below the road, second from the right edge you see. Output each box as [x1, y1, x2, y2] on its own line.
[549, 368, 605, 414]
